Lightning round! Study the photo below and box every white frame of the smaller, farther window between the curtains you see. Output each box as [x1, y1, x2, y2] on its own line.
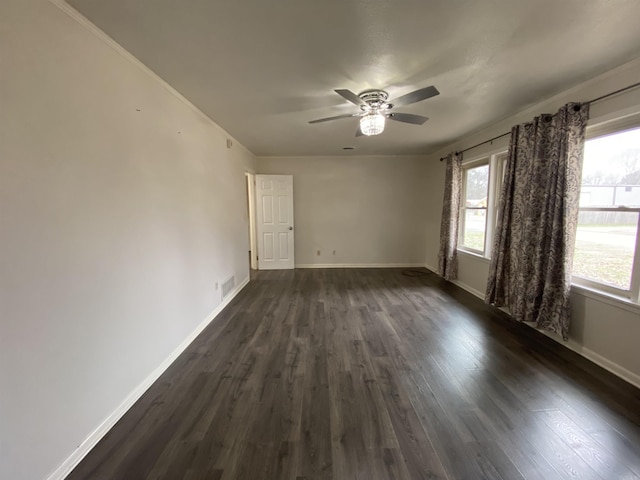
[458, 147, 508, 260]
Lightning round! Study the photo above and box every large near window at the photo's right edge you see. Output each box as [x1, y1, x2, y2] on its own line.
[573, 121, 640, 301]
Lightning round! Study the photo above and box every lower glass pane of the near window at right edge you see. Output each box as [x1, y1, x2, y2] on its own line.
[573, 212, 638, 290]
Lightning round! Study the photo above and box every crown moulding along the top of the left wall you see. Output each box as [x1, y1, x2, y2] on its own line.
[49, 0, 255, 161]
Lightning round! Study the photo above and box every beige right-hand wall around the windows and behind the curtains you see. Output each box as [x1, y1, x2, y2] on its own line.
[426, 60, 640, 386]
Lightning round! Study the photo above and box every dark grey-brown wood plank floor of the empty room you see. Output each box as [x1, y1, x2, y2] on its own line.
[68, 269, 640, 480]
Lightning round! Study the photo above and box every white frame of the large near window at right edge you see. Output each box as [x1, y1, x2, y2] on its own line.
[571, 112, 640, 304]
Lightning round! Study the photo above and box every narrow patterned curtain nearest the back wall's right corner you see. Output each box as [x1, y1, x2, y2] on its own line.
[438, 153, 462, 280]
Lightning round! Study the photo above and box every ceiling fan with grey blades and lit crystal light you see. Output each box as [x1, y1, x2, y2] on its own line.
[309, 85, 440, 137]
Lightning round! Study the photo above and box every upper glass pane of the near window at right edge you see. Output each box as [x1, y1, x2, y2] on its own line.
[580, 128, 640, 207]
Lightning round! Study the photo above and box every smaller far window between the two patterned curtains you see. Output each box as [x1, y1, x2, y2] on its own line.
[458, 152, 506, 258]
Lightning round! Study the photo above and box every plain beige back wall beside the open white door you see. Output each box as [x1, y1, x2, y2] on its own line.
[258, 156, 427, 267]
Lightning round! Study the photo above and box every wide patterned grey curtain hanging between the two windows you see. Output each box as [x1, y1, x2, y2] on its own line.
[485, 103, 589, 340]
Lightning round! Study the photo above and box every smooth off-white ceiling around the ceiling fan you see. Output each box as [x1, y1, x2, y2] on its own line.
[68, 0, 640, 156]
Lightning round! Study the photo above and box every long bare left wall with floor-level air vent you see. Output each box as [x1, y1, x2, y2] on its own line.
[0, 0, 255, 480]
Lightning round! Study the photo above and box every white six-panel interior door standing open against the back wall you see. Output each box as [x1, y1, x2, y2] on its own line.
[256, 175, 294, 270]
